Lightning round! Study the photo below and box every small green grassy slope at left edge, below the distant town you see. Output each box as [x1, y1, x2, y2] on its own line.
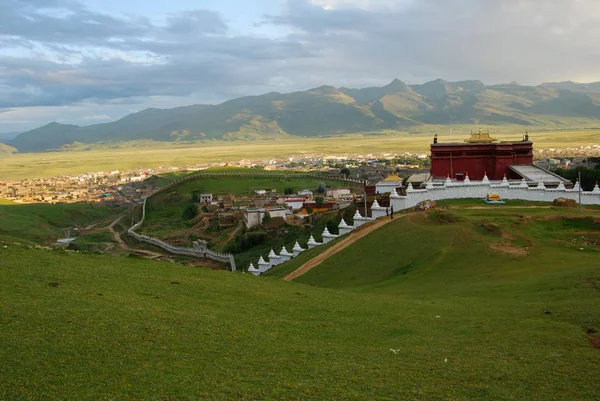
[0, 201, 122, 243]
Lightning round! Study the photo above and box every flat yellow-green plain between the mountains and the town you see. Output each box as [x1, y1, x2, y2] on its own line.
[0, 126, 600, 180]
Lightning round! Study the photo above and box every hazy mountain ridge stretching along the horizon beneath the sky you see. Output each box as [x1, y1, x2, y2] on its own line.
[9, 79, 600, 152]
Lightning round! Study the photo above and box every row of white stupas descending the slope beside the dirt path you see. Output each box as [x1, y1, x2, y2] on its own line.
[248, 209, 370, 276]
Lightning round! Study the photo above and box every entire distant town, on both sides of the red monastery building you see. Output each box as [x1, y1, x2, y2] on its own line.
[0, 145, 600, 206]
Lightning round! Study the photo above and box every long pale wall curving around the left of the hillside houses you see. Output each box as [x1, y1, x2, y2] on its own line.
[127, 172, 362, 272]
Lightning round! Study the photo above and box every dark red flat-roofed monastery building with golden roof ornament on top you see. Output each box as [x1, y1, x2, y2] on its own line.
[431, 131, 533, 180]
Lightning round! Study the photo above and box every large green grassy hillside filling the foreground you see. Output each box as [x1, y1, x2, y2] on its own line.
[0, 206, 600, 400]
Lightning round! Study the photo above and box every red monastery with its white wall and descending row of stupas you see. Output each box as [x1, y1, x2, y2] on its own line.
[248, 132, 600, 275]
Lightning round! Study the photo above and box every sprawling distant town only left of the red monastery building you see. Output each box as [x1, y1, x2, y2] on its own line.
[0, 154, 425, 205]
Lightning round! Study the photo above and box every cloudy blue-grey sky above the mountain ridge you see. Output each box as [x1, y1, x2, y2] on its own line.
[0, 0, 600, 132]
